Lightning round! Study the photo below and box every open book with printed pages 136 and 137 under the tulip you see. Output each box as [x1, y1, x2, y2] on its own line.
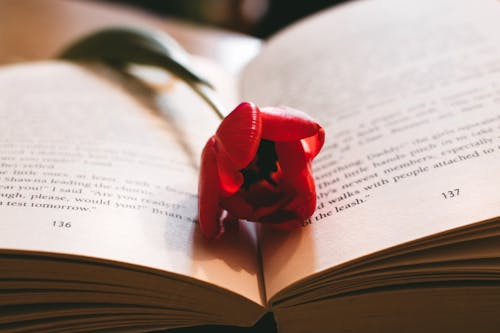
[0, 0, 500, 332]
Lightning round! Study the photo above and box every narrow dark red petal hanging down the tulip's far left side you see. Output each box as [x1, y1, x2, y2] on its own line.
[198, 137, 221, 239]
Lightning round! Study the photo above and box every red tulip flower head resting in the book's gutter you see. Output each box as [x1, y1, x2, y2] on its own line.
[198, 103, 325, 238]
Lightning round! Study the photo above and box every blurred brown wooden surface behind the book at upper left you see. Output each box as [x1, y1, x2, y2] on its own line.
[0, 0, 261, 72]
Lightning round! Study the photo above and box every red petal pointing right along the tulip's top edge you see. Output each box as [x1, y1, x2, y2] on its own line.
[260, 106, 321, 141]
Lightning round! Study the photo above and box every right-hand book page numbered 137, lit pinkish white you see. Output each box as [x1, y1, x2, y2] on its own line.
[242, 0, 500, 298]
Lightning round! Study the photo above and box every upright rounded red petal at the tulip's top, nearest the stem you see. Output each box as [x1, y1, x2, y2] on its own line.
[215, 103, 262, 169]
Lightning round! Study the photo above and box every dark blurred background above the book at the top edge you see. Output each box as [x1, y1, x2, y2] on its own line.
[99, 0, 345, 39]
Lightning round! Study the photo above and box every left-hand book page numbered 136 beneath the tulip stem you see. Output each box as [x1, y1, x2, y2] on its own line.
[0, 62, 261, 304]
